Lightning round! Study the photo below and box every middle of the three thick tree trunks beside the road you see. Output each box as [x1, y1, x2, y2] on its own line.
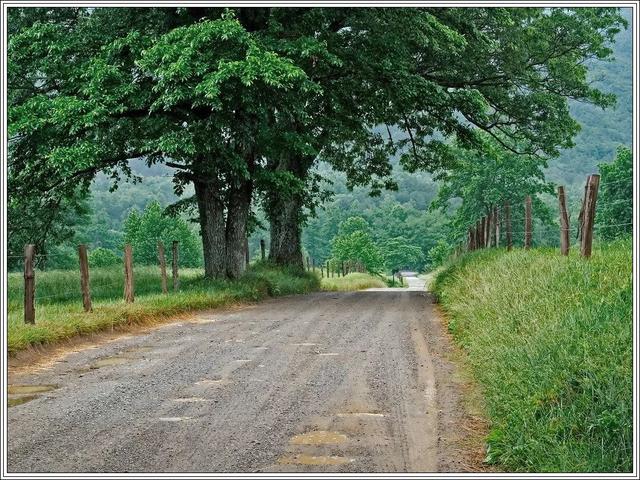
[226, 180, 252, 278]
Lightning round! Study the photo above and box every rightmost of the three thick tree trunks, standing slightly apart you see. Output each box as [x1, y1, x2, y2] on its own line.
[269, 195, 304, 270]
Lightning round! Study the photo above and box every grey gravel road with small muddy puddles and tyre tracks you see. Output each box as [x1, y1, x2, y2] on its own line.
[7, 282, 476, 472]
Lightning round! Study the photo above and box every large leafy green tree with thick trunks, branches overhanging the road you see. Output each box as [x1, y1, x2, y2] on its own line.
[9, 8, 623, 277]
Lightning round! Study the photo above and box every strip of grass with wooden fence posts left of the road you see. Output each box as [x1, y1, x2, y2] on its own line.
[7, 265, 320, 354]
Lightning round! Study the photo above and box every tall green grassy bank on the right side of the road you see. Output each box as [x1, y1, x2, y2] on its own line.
[433, 240, 633, 472]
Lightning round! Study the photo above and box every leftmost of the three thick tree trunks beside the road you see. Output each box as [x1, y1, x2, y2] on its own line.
[194, 182, 226, 278]
